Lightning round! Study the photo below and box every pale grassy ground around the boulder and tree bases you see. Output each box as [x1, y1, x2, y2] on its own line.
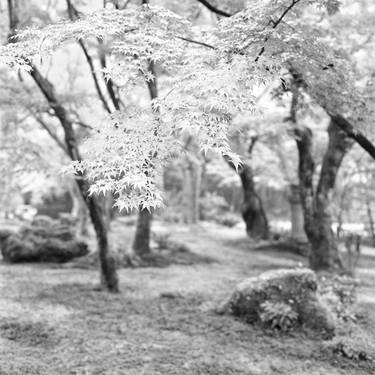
[0, 224, 375, 375]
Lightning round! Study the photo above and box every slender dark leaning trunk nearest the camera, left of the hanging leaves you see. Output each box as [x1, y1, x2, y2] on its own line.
[30, 64, 118, 292]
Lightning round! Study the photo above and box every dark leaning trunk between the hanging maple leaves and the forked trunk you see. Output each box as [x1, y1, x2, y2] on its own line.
[239, 163, 269, 239]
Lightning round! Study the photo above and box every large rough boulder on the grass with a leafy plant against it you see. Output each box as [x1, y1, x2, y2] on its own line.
[221, 268, 335, 338]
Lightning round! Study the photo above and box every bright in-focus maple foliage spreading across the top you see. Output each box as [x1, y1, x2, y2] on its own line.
[0, 0, 375, 276]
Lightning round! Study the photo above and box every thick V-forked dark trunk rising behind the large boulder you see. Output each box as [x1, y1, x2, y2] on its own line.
[296, 120, 353, 270]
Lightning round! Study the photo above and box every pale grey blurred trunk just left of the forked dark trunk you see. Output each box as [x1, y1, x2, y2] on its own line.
[289, 184, 308, 242]
